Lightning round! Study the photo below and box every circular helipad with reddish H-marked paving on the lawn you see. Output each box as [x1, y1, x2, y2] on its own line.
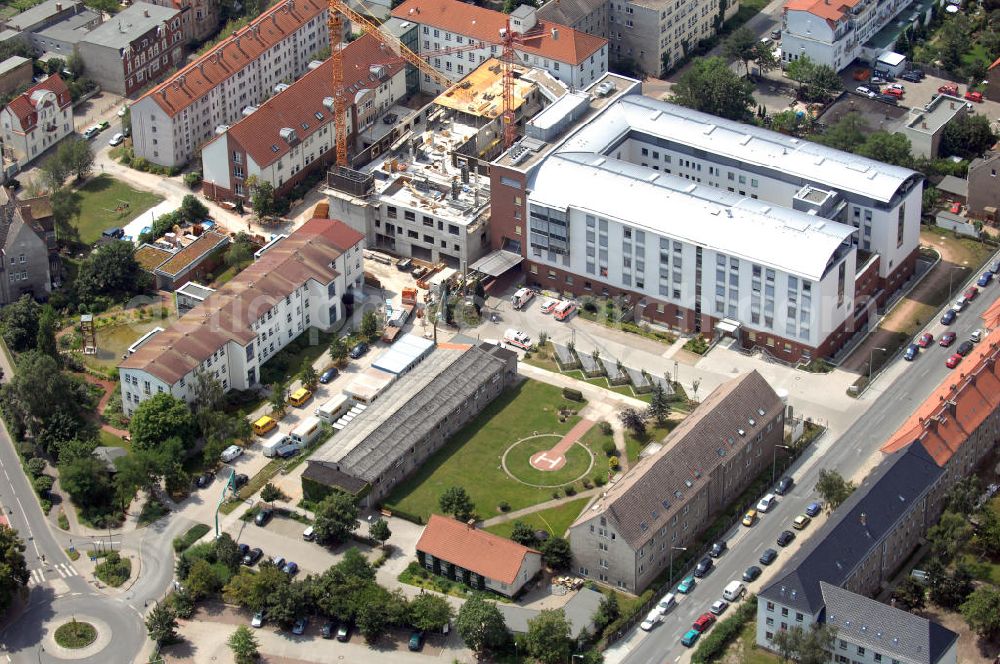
[501, 433, 594, 489]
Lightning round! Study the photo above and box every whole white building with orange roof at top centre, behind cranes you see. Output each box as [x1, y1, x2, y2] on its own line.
[392, 0, 608, 94]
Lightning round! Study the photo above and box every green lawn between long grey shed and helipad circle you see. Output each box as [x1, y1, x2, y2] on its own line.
[386, 380, 586, 519]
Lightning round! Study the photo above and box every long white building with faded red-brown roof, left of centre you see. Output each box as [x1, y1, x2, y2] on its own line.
[118, 218, 364, 416]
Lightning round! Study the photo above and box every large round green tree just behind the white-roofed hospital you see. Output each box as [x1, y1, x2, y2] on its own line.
[673, 57, 756, 121]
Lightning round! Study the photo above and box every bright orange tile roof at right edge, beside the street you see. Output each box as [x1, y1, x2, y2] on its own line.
[882, 330, 1000, 467]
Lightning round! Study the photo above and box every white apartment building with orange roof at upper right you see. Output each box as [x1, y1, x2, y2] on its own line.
[781, 0, 943, 71]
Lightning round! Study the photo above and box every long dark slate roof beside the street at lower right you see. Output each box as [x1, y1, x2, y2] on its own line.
[759, 445, 944, 616]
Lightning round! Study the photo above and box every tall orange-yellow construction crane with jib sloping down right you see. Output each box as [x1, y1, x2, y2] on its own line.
[327, 0, 453, 167]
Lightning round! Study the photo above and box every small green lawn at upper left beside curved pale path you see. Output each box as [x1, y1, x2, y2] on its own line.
[73, 175, 163, 245]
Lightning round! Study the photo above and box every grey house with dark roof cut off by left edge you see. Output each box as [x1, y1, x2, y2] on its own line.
[0, 187, 59, 305]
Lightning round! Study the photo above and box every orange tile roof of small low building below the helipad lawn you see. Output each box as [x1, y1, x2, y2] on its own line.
[417, 514, 541, 584]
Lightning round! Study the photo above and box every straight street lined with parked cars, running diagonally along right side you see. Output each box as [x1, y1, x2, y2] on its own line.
[606, 258, 1000, 664]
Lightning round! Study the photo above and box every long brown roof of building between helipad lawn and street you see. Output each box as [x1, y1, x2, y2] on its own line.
[574, 371, 784, 549]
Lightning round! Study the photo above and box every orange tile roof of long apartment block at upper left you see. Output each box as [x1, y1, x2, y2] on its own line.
[143, 0, 327, 117]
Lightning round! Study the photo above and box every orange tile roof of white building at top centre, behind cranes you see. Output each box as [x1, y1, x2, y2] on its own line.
[392, 0, 608, 65]
